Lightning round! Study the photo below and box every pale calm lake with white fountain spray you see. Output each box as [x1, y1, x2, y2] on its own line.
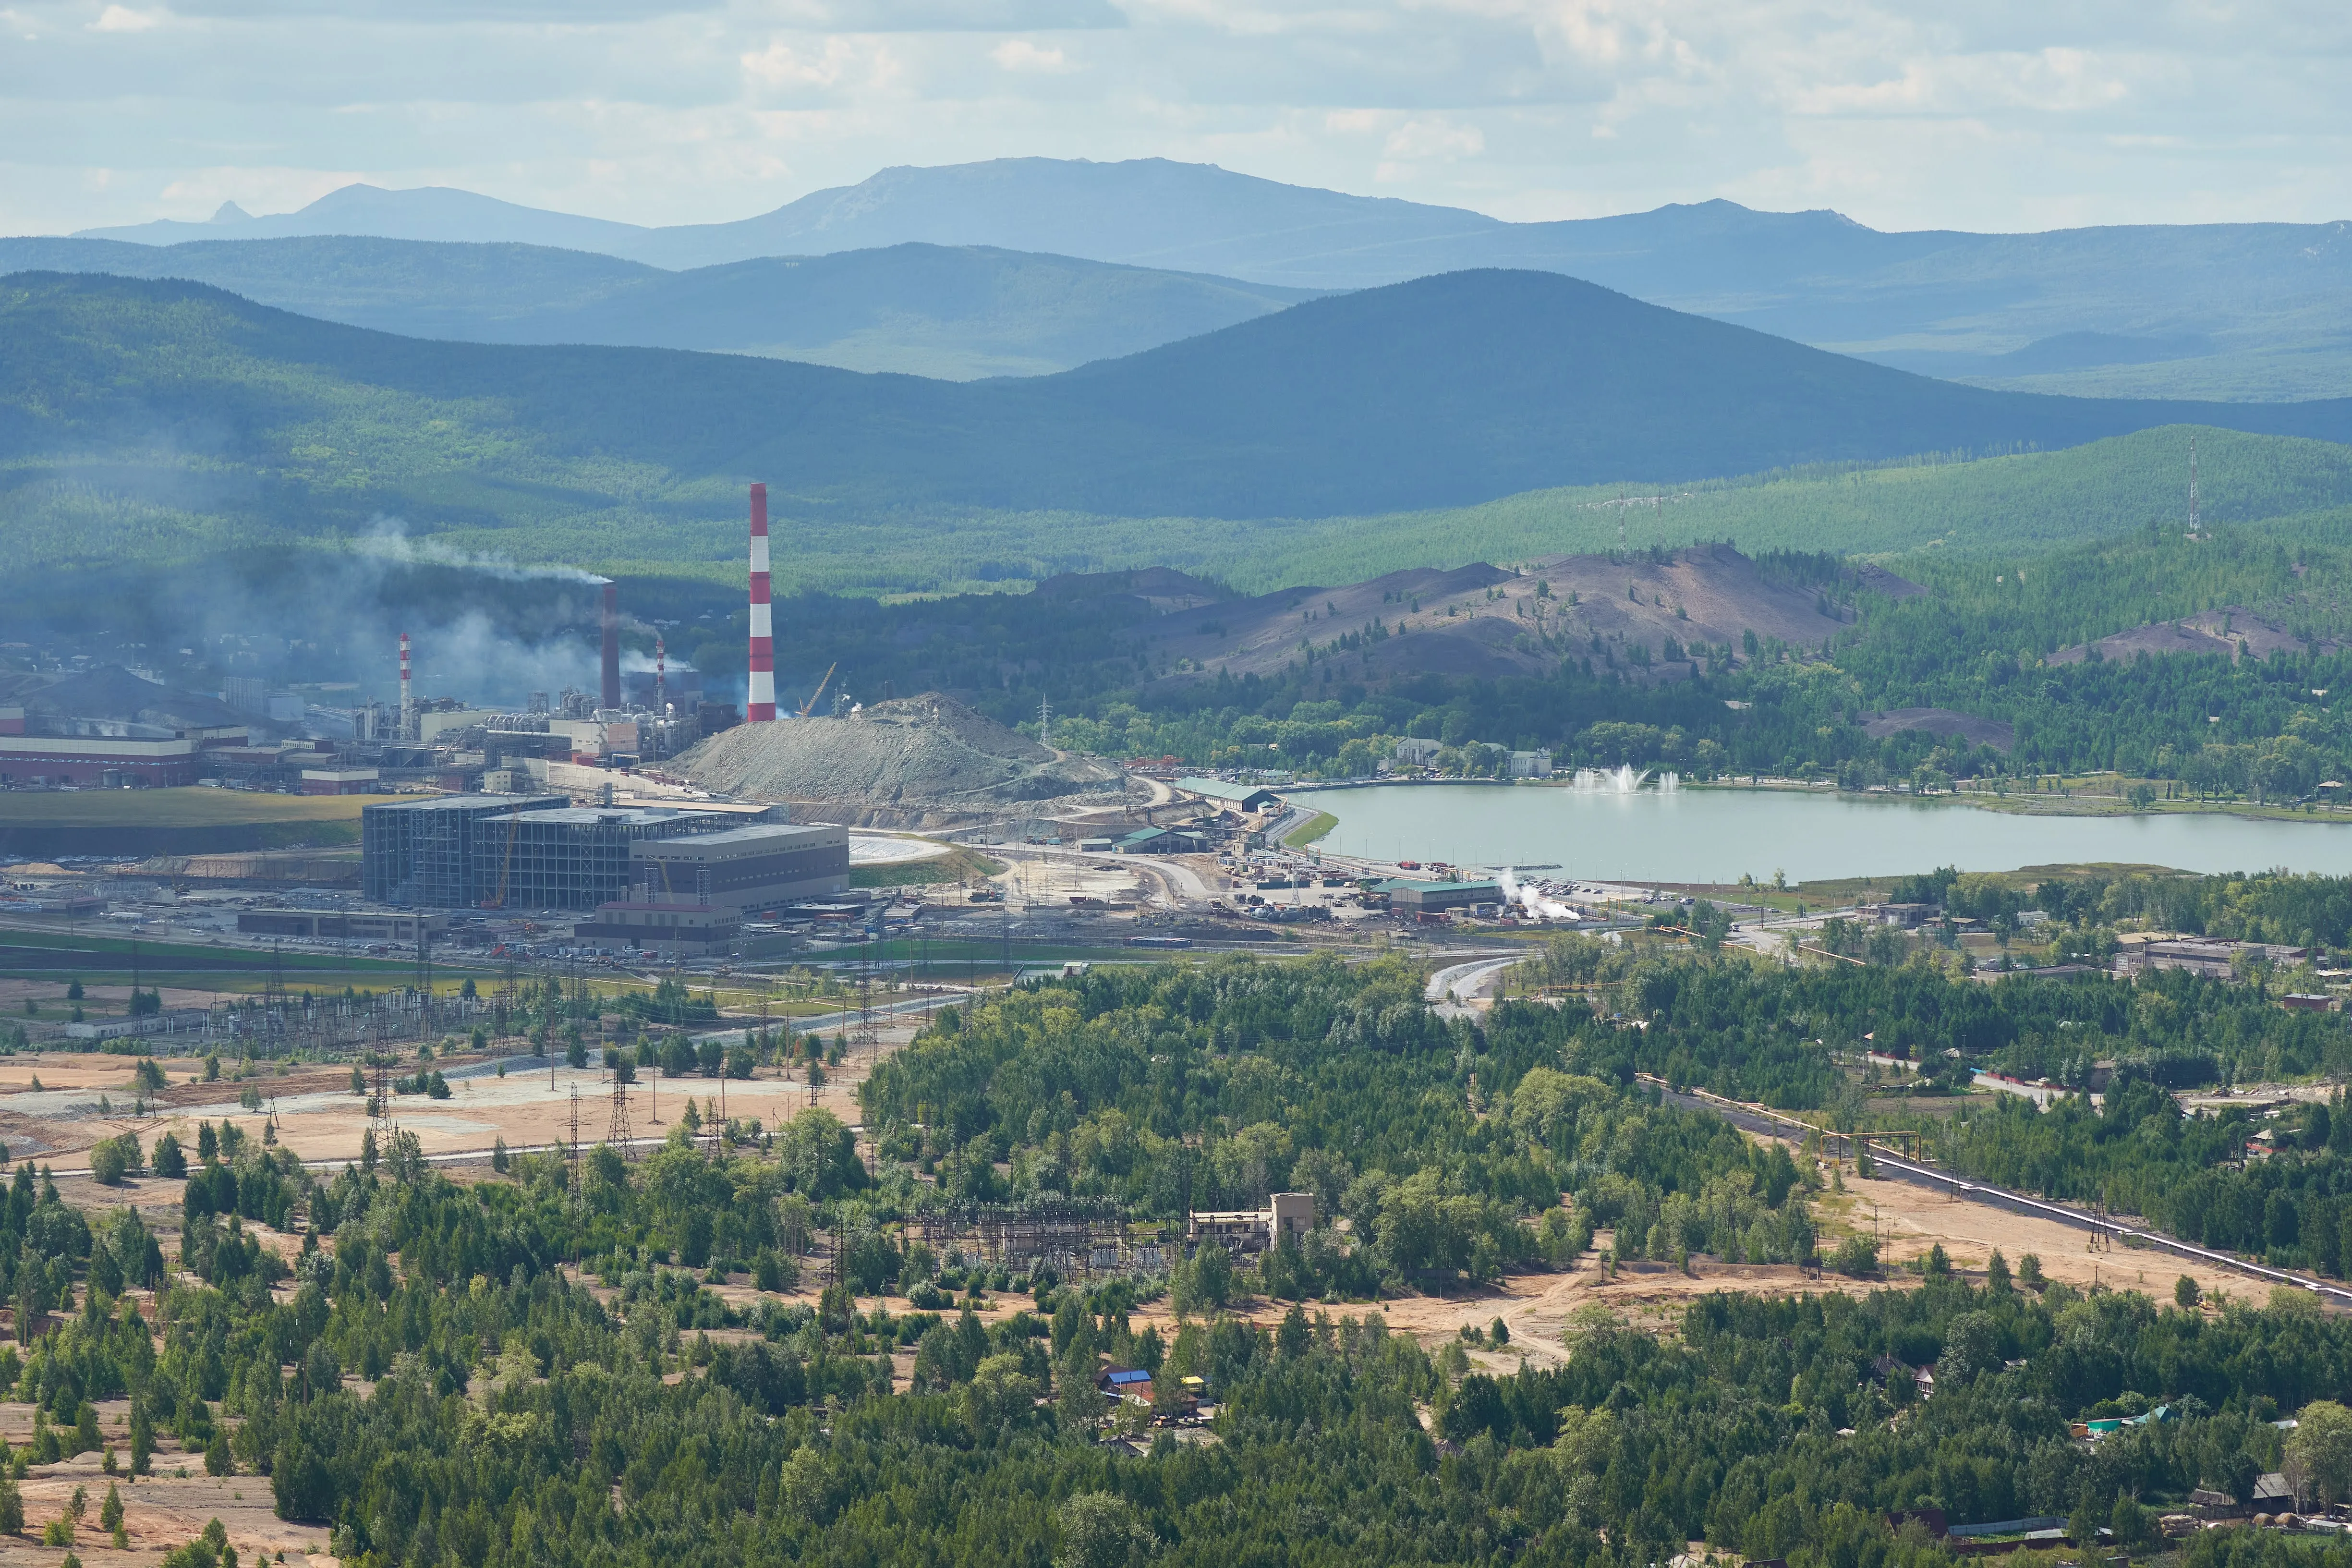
[1289, 785, 2352, 882]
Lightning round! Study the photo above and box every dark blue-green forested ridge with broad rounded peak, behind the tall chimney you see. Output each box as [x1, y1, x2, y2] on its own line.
[13, 273, 2352, 540]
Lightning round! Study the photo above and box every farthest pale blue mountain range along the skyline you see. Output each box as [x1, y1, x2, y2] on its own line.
[42, 158, 2352, 400]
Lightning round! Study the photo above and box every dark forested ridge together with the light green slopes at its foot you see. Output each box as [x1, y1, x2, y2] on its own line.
[13, 273, 2352, 593]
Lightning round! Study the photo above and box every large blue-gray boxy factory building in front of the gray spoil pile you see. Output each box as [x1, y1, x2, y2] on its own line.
[360, 795, 849, 912]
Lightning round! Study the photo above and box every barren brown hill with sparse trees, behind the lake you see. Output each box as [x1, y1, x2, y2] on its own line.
[1143, 546, 1891, 682]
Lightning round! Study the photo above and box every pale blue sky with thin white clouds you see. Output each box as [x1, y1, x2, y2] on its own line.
[0, 0, 2352, 233]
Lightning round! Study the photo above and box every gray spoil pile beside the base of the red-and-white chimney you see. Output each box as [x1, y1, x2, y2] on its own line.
[675, 693, 1119, 823]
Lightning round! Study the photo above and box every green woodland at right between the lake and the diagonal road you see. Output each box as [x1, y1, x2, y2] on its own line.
[1512, 872, 2352, 1279]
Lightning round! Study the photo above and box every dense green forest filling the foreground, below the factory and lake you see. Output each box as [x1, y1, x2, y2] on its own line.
[13, 945, 2352, 1568]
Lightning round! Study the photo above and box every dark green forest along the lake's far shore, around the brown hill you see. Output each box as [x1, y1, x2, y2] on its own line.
[696, 517, 2352, 799]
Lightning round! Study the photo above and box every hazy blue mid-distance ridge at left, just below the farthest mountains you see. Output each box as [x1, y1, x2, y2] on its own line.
[0, 235, 1315, 381]
